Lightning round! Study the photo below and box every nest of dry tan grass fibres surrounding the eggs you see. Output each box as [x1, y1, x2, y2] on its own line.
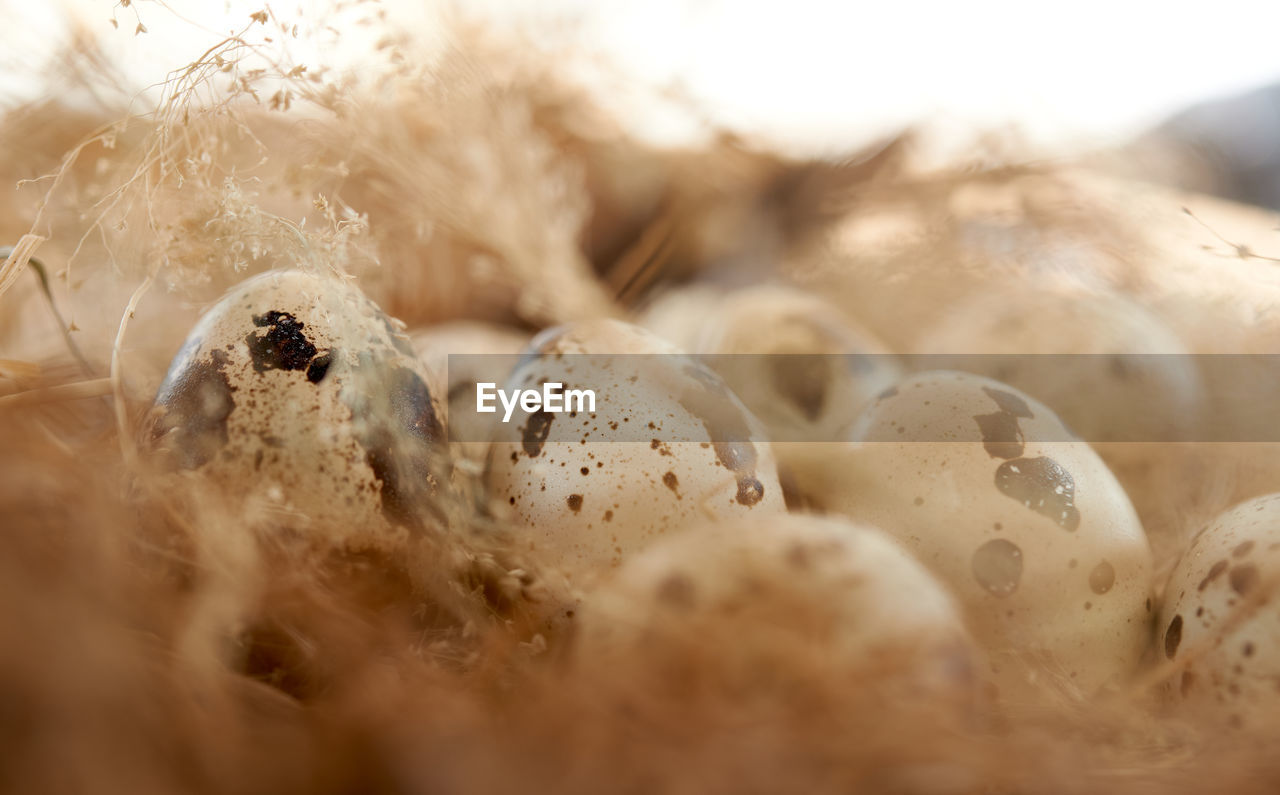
[0, 4, 1280, 792]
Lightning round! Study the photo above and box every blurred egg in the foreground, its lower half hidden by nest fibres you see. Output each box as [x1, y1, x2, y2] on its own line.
[575, 513, 975, 694]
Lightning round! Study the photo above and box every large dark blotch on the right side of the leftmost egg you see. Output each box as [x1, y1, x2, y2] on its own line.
[342, 353, 447, 529]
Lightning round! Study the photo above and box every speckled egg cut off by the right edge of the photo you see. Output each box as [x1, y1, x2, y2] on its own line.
[1156, 494, 1280, 725]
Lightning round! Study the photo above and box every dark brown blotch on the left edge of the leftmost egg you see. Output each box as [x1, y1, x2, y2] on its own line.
[151, 339, 236, 470]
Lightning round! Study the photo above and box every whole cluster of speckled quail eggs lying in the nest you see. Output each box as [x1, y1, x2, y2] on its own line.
[146, 262, 1280, 714]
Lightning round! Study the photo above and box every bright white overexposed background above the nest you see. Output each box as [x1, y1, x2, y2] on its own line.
[0, 0, 1280, 154]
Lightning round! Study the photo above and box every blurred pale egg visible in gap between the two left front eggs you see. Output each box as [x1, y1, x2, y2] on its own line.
[411, 320, 530, 466]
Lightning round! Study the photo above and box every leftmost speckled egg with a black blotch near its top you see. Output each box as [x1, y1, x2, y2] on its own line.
[147, 270, 445, 547]
